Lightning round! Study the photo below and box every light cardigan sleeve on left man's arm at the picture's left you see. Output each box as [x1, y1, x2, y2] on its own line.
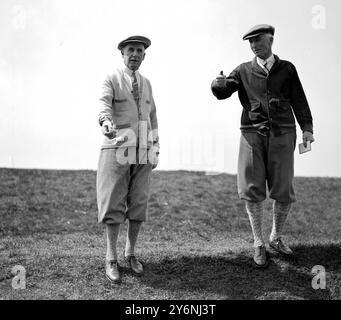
[98, 76, 115, 125]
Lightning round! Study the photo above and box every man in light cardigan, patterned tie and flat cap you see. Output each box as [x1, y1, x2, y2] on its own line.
[97, 36, 159, 283]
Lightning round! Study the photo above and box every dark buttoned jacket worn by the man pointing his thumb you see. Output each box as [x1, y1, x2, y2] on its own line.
[211, 55, 313, 135]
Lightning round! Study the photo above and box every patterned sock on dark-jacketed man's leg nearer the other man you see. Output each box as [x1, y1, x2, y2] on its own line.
[245, 201, 264, 247]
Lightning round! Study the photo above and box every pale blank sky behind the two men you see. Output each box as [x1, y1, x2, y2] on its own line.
[0, 0, 341, 177]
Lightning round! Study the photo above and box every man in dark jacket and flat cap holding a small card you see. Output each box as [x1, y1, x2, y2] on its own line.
[211, 25, 314, 268]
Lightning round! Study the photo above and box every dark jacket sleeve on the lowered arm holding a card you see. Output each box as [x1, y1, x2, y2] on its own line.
[290, 65, 313, 133]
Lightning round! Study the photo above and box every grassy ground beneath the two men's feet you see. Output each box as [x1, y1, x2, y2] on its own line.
[0, 169, 341, 300]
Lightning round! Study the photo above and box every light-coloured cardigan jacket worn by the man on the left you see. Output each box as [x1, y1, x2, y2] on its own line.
[98, 68, 159, 149]
